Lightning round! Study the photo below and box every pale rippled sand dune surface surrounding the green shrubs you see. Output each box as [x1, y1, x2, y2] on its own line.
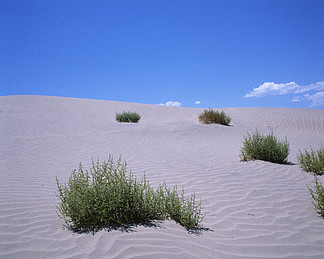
[0, 96, 324, 259]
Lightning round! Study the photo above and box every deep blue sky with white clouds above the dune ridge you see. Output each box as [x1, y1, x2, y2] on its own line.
[0, 0, 324, 109]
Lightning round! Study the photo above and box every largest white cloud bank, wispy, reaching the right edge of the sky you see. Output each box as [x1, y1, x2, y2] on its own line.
[244, 81, 324, 107]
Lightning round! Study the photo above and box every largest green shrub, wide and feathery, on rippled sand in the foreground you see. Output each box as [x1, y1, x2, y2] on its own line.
[56, 156, 203, 232]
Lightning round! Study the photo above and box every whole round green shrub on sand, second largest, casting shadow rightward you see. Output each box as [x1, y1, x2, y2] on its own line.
[241, 130, 289, 164]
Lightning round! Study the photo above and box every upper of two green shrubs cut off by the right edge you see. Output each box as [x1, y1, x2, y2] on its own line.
[297, 146, 324, 175]
